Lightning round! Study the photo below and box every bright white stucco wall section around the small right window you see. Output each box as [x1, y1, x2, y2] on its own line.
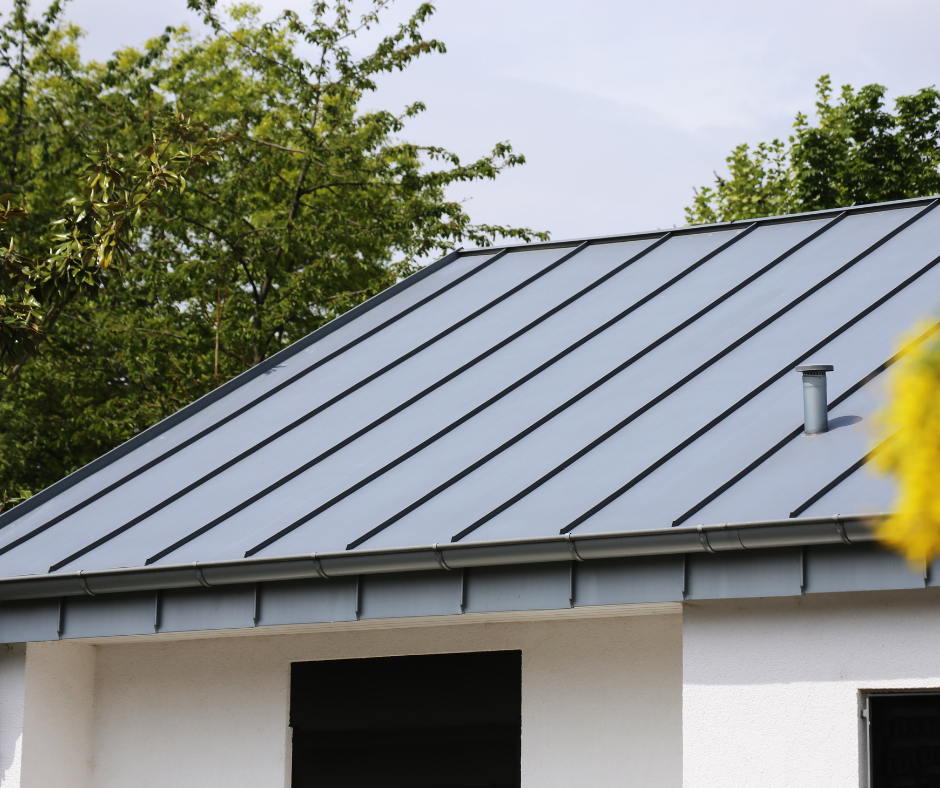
[682, 589, 940, 788]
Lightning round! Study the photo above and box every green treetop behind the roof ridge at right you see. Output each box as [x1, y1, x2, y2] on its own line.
[685, 76, 940, 224]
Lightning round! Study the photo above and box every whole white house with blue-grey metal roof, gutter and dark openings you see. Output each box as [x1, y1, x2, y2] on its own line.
[0, 199, 940, 788]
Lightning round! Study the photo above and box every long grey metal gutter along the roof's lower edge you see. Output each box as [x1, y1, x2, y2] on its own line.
[0, 514, 888, 601]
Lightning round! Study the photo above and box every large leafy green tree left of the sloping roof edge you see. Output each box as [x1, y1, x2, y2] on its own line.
[0, 0, 546, 504]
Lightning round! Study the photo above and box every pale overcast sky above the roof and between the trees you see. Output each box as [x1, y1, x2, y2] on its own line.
[0, 0, 940, 239]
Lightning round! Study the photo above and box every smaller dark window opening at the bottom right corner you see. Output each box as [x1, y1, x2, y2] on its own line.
[868, 692, 940, 788]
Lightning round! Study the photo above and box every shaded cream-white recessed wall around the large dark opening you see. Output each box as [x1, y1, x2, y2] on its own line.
[73, 614, 682, 788]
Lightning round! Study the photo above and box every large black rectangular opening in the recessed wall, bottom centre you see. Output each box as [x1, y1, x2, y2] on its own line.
[290, 651, 522, 788]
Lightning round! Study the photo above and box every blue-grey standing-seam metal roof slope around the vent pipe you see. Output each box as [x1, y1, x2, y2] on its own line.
[0, 195, 940, 577]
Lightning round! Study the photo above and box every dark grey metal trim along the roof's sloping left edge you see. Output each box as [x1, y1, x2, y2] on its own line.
[0, 247, 466, 528]
